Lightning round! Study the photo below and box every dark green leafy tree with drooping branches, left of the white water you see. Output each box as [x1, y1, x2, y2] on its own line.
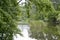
[0, 0, 20, 40]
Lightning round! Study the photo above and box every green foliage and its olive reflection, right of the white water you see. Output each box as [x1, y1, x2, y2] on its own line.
[16, 0, 60, 40]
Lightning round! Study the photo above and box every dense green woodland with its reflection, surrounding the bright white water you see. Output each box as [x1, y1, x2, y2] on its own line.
[0, 0, 60, 40]
